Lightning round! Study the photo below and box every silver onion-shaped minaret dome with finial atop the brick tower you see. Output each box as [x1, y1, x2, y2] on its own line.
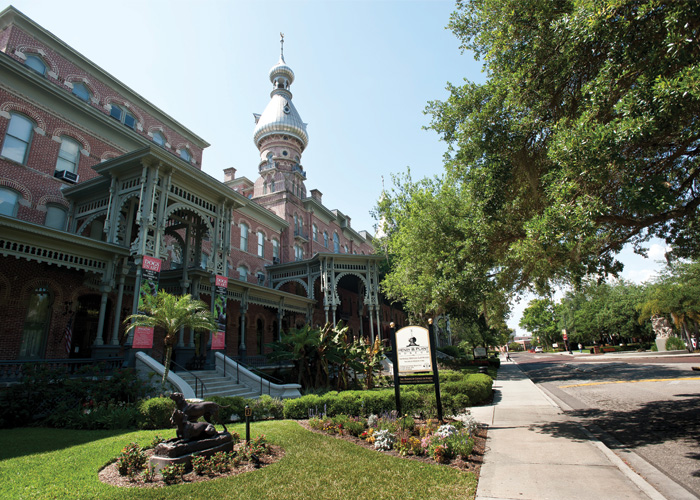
[253, 37, 309, 150]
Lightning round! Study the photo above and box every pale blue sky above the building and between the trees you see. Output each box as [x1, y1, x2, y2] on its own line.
[5, 0, 658, 336]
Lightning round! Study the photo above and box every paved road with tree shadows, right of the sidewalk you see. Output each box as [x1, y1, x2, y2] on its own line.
[512, 354, 700, 498]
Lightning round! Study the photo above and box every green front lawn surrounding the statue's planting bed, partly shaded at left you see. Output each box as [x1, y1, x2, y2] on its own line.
[0, 421, 476, 500]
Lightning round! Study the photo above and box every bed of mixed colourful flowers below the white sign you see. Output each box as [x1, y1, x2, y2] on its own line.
[305, 411, 486, 470]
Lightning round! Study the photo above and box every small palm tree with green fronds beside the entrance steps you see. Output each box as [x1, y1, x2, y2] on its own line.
[124, 291, 216, 385]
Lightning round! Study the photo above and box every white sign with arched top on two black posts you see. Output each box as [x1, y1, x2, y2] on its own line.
[390, 319, 442, 421]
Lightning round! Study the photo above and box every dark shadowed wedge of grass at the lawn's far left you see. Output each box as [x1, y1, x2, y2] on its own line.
[0, 427, 134, 460]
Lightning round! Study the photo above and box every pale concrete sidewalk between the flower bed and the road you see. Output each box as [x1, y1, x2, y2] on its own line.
[471, 362, 680, 500]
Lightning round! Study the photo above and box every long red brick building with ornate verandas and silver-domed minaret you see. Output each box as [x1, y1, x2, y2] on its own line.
[0, 7, 405, 378]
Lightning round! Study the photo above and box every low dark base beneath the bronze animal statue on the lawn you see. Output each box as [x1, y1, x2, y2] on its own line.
[149, 432, 233, 472]
